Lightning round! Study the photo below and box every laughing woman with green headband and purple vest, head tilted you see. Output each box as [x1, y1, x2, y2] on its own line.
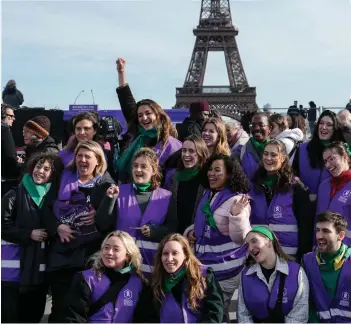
[237, 226, 309, 323]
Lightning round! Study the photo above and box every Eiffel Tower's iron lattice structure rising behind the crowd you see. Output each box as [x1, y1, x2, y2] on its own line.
[174, 0, 257, 117]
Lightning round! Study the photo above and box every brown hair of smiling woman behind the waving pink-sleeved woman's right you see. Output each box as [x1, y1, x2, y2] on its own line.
[253, 140, 294, 193]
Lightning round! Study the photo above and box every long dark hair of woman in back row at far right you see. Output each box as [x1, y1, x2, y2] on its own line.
[307, 110, 346, 169]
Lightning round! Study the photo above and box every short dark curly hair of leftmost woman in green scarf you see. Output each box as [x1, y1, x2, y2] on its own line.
[26, 152, 63, 183]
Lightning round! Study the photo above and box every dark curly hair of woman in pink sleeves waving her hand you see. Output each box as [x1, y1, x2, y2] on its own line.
[204, 154, 250, 194]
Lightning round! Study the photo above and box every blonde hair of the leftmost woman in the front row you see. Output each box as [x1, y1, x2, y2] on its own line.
[89, 231, 144, 279]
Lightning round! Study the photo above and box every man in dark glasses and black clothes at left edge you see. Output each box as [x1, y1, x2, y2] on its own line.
[1, 104, 21, 196]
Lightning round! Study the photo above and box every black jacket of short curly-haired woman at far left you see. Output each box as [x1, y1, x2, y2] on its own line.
[1, 183, 57, 286]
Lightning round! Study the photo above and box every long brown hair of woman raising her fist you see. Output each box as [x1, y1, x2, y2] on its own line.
[128, 99, 177, 147]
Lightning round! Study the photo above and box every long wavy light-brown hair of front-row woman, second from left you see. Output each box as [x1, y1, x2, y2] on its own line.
[152, 234, 206, 311]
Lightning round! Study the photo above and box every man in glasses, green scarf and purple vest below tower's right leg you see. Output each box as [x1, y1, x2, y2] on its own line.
[232, 112, 272, 181]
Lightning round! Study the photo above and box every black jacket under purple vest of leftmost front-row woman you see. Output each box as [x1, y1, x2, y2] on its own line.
[65, 269, 157, 323]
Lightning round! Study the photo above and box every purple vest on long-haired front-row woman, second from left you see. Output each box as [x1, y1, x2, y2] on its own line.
[160, 267, 207, 323]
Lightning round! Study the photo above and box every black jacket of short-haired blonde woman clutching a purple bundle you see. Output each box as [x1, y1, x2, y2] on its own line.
[45, 172, 114, 272]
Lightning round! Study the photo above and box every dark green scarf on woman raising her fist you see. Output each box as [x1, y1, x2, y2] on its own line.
[117, 125, 157, 175]
